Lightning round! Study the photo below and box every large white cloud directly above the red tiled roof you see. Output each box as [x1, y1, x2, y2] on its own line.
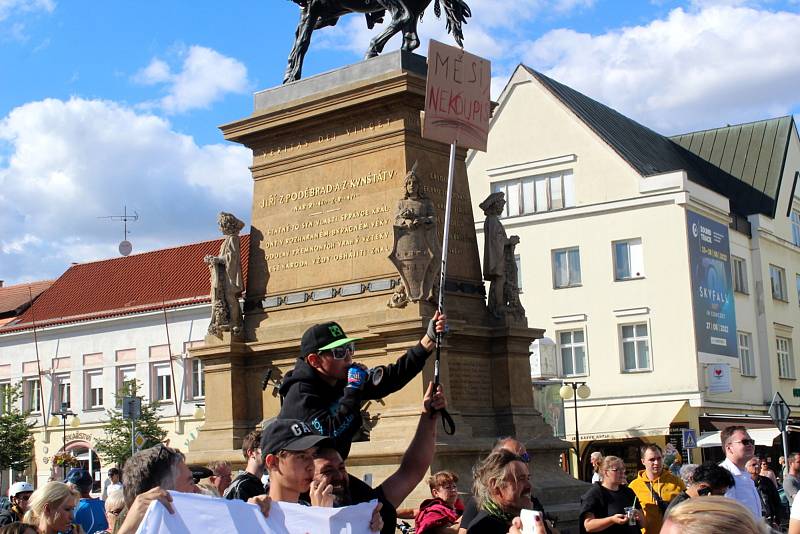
[0, 98, 252, 283]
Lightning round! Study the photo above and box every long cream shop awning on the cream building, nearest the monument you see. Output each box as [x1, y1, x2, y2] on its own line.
[564, 401, 686, 441]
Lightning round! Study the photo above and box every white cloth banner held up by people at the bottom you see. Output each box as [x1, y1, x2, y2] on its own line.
[136, 491, 377, 534]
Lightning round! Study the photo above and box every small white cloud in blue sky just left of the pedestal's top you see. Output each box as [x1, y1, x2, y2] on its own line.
[133, 45, 250, 113]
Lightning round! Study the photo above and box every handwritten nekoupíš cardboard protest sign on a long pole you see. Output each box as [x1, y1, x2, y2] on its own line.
[422, 40, 491, 434]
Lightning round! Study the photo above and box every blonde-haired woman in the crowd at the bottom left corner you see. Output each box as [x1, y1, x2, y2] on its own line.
[24, 482, 85, 534]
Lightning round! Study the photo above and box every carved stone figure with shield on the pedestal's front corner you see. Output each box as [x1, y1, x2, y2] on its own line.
[387, 162, 442, 308]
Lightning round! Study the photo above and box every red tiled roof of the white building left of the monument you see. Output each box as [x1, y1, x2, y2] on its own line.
[0, 235, 250, 332]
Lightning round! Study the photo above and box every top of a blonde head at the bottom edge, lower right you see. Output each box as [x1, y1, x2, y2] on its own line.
[661, 495, 771, 534]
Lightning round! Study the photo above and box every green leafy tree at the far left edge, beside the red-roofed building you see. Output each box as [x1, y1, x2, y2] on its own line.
[0, 384, 34, 492]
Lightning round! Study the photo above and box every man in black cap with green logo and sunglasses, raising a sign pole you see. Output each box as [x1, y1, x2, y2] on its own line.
[278, 311, 447, 459]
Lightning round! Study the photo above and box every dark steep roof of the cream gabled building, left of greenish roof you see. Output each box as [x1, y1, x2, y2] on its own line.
[523, 65, 775, 216]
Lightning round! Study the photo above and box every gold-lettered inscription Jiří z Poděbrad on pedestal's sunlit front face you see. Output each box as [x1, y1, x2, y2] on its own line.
[253, 162, 402, 293]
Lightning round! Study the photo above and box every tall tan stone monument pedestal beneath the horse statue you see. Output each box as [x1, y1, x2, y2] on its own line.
[190, 52, 583, 528]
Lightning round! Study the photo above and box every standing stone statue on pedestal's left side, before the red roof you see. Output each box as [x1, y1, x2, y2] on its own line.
[203, 212, 244, 336]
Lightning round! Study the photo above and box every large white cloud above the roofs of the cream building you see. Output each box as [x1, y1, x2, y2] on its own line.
[518, 6, 800, 133]
